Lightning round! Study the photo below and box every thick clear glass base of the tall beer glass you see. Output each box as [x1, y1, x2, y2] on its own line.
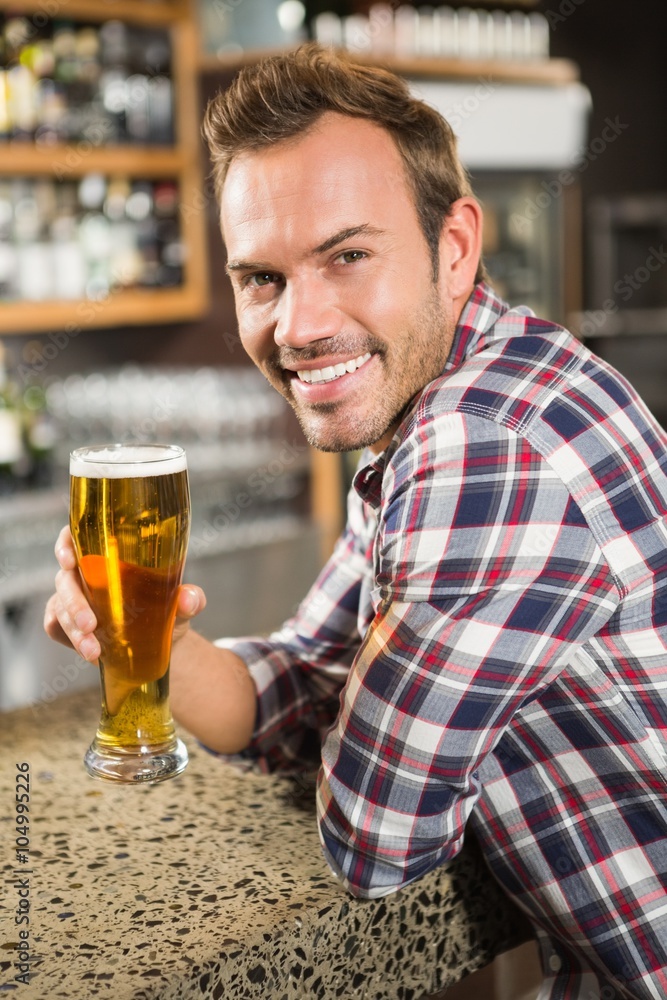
[83, 739, 188, 784]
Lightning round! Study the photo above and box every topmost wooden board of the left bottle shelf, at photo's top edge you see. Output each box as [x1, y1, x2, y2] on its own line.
[0, 0, 188, 24]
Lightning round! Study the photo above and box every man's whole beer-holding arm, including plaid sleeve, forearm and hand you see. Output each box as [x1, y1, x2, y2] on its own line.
[45, 478, 375, 769]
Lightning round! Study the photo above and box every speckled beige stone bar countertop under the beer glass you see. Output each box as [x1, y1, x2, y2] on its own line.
[0, 692, 526, 1000]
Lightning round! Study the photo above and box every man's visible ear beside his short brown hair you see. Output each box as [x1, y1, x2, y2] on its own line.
[440, 198, 483, 304]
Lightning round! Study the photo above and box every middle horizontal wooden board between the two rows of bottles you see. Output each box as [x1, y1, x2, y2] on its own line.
[0, 142, 186, 180]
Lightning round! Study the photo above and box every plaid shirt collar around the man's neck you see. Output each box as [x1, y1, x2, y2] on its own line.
[352, 281, 509, 510]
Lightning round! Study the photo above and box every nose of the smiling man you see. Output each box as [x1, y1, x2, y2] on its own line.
[274, 277, 343, 348]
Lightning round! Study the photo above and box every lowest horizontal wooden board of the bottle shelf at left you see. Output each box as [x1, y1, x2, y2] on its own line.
[0, 285, 206, 338]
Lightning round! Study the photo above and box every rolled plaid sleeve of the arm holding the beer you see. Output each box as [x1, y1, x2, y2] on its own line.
[217, 480, 377, 771]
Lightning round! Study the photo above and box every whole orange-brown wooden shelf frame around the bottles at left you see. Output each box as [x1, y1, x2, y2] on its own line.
[0, 0, 209, 336]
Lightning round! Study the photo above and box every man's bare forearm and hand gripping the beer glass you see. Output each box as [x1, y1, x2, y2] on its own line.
[44, 528, 257, 754]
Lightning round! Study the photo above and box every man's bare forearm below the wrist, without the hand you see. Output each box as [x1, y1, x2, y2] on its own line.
[169, 630, 257, 753]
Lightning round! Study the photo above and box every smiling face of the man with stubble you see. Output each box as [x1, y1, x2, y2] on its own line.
[221, 113, 458, 451]
